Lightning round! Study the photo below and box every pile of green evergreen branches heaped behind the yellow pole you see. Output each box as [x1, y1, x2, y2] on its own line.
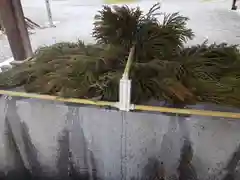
[0, 4, 240, 107]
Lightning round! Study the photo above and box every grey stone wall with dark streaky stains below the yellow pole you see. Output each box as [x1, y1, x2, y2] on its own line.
[0, 96, 240, 180]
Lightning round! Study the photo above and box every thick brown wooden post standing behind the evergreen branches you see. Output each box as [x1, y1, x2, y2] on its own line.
[0, 0, 32, 61]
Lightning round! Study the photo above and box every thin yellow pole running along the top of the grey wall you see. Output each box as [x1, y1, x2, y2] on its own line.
[0, 90, 240, 119]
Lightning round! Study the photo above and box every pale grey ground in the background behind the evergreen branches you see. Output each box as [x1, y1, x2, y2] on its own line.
[0, 0, 240, 63]
